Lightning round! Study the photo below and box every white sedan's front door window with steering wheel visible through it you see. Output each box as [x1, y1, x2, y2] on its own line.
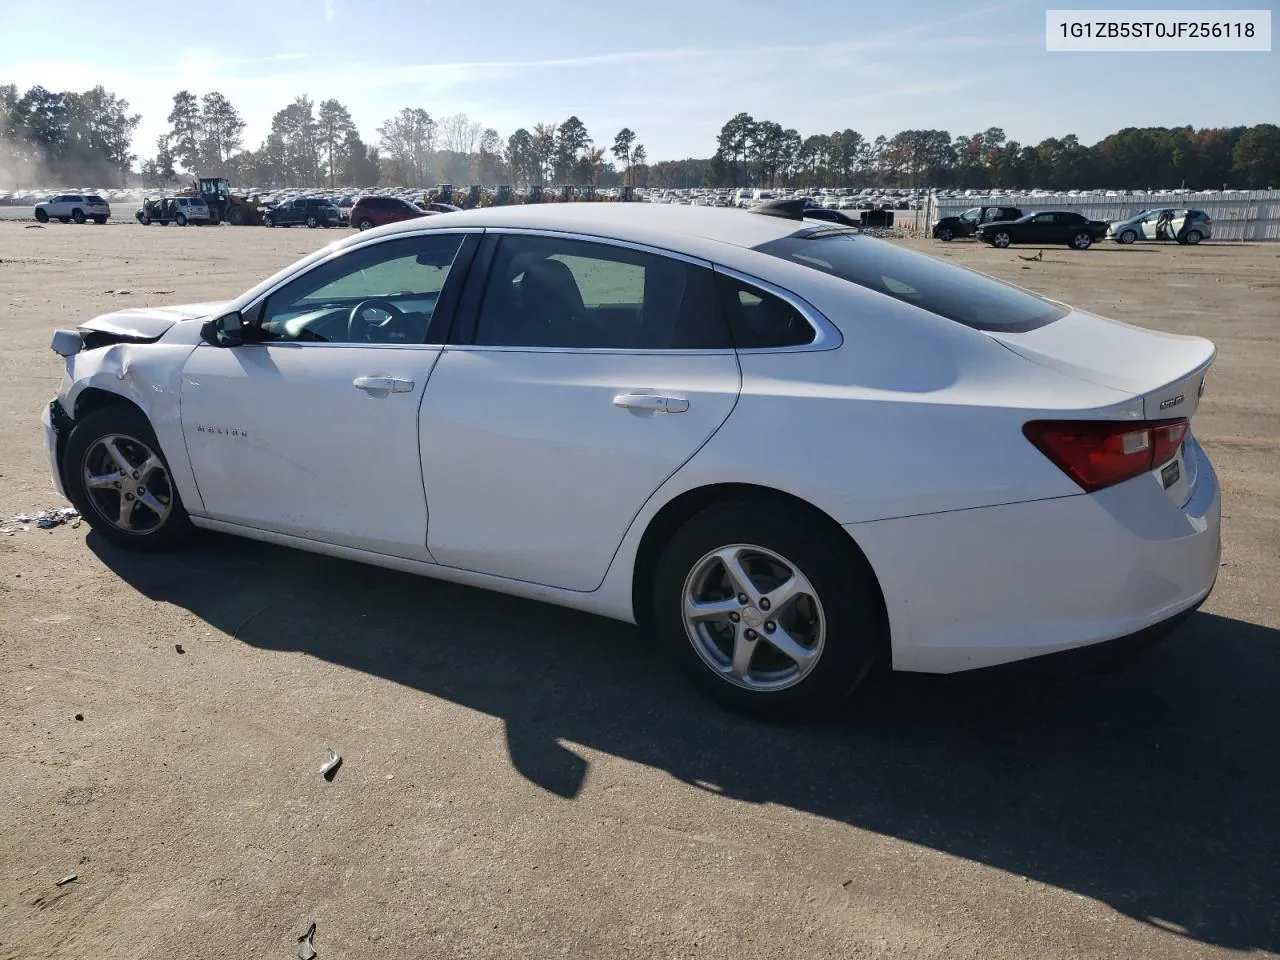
[259, 232, 463, 343]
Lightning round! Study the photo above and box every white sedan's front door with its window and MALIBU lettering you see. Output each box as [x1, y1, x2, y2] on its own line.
[182, 230, 470, 559]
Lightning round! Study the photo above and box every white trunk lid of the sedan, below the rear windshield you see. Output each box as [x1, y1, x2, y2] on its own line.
[986, 310, 1217, 506]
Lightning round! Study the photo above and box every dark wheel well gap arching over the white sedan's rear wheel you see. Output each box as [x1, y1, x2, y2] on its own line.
[631, 484, 892, 666]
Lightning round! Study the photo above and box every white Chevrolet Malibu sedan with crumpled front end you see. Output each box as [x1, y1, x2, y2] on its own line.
[45, 204, 1220, 714]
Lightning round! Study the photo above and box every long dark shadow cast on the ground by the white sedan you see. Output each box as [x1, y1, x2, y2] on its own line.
[88, 534, 1280, 950]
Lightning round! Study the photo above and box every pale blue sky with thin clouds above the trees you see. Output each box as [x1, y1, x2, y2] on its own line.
[0, 0, 1280, 163]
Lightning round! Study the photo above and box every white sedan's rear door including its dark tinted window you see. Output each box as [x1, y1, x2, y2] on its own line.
[420, 230, 741, 590]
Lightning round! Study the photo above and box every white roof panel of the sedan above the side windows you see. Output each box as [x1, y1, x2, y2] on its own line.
[343, 202, 798, 257]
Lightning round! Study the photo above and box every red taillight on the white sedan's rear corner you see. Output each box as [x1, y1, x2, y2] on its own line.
[1023, 420, 1187, 493]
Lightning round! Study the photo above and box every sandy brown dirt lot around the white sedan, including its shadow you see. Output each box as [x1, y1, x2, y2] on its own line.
[0, 223, 1280, 960]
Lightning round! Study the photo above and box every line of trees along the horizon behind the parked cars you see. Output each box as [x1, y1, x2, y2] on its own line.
[0, 84, 1280, 189]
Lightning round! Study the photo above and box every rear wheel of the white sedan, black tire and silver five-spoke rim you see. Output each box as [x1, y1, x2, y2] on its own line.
[652, 498, 886, 718]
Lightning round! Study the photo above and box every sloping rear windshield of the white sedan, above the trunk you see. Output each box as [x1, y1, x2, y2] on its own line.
[756, 228, 1068, 333]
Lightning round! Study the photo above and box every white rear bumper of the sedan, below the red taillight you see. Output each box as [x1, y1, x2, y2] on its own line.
[845, 443, 1221, 673]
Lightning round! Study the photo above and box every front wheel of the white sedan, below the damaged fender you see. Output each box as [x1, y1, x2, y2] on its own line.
[61, 404, 193, 552]
